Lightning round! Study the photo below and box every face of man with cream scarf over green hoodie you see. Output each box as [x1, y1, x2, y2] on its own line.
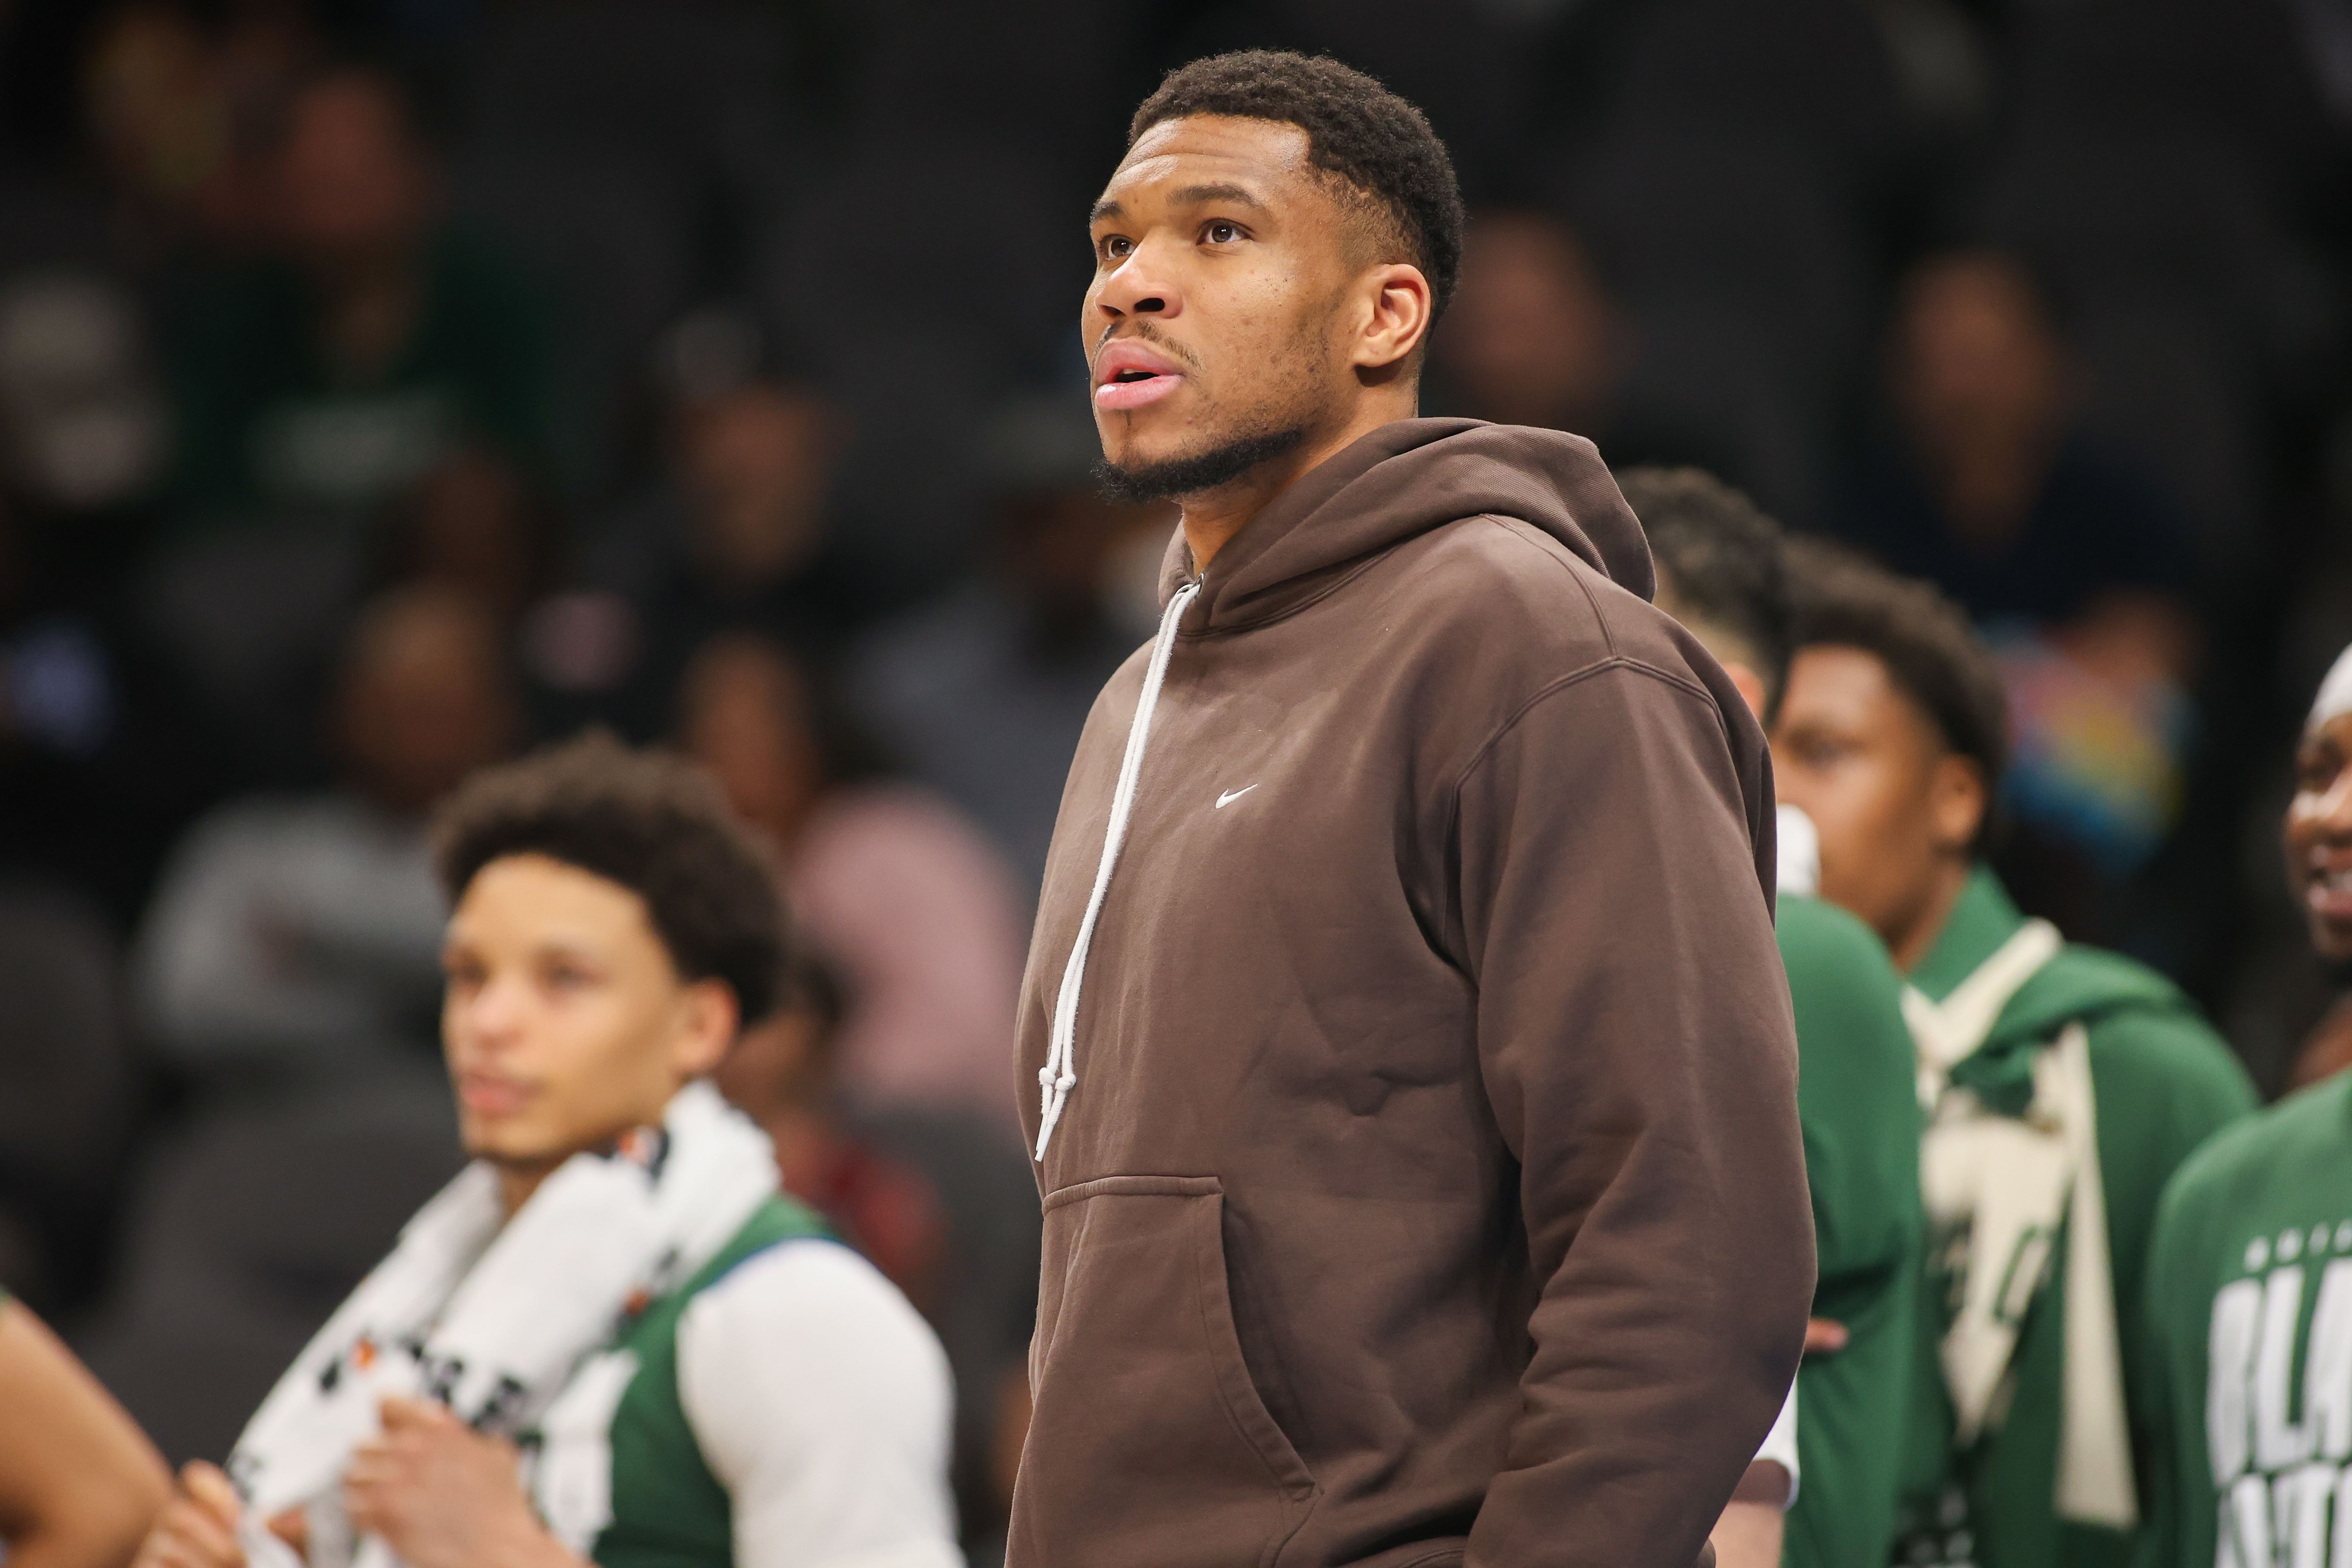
[1771, 646, 1985, 952]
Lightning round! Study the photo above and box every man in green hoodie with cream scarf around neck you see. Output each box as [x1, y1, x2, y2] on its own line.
[1771, 543, 2253, 1568]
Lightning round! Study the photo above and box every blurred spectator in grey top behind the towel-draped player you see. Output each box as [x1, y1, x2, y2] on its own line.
[134, 588, 515, 1070]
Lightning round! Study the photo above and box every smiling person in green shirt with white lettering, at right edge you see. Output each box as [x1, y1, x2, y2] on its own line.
[2138, 649, 2352, 1568]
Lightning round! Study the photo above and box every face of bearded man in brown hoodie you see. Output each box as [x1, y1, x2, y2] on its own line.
[1080, 115, 1364, 491]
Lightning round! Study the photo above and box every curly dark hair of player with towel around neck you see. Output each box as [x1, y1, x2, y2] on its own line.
[433, 731, 788, 1023]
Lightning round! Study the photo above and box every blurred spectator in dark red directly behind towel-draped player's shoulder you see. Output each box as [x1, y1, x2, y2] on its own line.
[712, 957, 946, 1321]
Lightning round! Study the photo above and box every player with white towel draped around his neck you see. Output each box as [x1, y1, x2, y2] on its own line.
[124, 736, 962, 1568]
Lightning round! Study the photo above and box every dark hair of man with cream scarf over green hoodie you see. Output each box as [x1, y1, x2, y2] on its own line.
[1788, 538, 2009, 851]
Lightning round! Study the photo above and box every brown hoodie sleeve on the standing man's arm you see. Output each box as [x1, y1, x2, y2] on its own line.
[1456, 661, 1813, 1568]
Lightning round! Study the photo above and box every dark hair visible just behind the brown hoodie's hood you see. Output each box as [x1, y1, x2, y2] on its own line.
[1618, 465, 1790, 724]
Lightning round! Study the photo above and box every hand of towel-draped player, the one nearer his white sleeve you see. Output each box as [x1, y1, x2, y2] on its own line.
[343, 1399, 578, 1568]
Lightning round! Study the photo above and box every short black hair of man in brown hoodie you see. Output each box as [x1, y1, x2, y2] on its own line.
[1127, 50, 1463, 322]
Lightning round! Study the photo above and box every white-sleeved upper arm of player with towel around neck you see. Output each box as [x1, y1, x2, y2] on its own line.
[678, 1241, 964, 1568]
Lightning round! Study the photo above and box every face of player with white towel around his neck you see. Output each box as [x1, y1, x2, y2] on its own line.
[442, 855, 734, 1171]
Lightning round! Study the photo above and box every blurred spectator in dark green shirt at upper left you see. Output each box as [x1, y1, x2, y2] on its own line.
[172, 66, 550, 512]
